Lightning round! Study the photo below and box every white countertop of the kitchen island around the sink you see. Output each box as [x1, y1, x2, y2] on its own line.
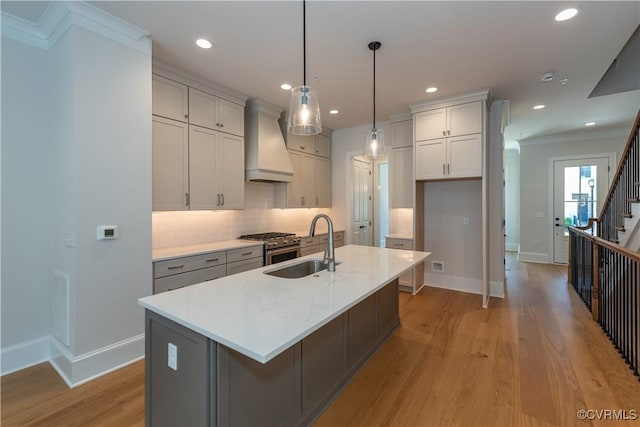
[138, 245, 430, 363]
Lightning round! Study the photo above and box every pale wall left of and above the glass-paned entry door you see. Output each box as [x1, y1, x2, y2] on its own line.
[519, 125, 631, 262]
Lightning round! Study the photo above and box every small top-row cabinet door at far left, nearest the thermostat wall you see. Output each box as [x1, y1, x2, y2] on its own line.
[151, 74, 189, 122]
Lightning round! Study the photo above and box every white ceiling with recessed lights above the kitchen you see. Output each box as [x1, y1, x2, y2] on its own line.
[2, 0, 640, 145]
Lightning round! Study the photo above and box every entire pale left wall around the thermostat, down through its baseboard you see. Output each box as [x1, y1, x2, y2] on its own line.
[2, 3, 152, 384]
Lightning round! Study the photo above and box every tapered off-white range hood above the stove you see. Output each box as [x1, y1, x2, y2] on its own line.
[244, 98, 293, 182]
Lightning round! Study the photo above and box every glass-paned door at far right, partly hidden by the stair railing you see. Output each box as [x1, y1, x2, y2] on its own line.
[553, 157, 610, 264]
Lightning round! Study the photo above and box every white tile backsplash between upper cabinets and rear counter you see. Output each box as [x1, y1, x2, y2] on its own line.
[152, 182, 331, 249]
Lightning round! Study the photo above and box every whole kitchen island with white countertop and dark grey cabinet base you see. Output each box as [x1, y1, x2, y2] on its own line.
[139, 246, 429, 426]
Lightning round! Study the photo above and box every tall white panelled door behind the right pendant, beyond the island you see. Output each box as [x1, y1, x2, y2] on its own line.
[351, 158, 373, 246]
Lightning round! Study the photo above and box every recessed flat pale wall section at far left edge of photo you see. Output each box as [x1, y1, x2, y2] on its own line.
[0, 37, 53, 365]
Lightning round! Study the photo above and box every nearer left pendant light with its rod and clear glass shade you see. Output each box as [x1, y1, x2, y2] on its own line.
[287, 0, 322, 135]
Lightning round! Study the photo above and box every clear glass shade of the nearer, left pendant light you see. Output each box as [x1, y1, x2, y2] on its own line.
[287, 86, 322, 135]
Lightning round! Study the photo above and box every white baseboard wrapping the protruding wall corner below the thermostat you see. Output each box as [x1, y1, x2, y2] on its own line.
[51, 334, 144, 387]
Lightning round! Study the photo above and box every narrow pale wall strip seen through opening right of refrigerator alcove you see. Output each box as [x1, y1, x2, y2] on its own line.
[504, 150, 520, 252]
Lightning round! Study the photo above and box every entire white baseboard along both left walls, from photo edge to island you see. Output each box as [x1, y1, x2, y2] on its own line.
[2, 334, 144, 387]
